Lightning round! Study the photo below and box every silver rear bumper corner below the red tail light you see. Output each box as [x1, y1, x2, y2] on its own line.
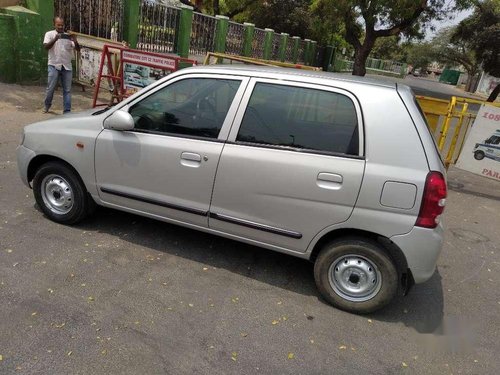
[391, 223, 444, 284]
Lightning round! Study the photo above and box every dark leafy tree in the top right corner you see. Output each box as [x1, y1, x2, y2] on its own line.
[453, 0, 500, 102]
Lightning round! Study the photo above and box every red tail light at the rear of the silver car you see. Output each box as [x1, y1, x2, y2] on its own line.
[415, 171, 446, 228]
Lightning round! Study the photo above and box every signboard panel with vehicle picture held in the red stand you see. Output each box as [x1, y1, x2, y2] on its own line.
[121, 50, 178, 95]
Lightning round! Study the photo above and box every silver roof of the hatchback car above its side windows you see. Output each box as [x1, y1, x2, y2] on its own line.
[183, 64, 397, 89]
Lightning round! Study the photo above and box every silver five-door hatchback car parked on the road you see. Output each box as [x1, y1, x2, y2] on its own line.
[17, 65, 446, 313]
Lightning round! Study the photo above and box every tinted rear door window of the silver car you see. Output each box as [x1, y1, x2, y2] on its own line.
[236, 83, 359, 155]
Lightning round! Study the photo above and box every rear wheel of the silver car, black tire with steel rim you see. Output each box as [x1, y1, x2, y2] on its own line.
[314, 237, 399, 314]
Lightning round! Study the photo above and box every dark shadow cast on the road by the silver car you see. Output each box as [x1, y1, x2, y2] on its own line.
[78, 207, 443, 333]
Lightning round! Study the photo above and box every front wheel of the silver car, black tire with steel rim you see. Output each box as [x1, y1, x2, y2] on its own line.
[33, 161, 95, 225]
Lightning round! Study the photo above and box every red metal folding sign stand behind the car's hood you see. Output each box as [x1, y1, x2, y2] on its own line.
[93, 44, 196, 107]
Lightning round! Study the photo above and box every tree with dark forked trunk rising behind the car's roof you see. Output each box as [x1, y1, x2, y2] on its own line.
[313, 0, 471, 76]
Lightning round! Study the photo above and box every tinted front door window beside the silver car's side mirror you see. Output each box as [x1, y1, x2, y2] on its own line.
[130, 78, 241, 138]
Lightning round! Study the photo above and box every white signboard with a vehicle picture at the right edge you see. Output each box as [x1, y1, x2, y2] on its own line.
[456, 105, 500, 181]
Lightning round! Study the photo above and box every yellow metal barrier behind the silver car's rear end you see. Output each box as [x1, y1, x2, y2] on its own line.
[417, 96, 500, 168]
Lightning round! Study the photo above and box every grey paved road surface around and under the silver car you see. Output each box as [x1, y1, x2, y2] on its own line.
[0, 84, 500, 374]
